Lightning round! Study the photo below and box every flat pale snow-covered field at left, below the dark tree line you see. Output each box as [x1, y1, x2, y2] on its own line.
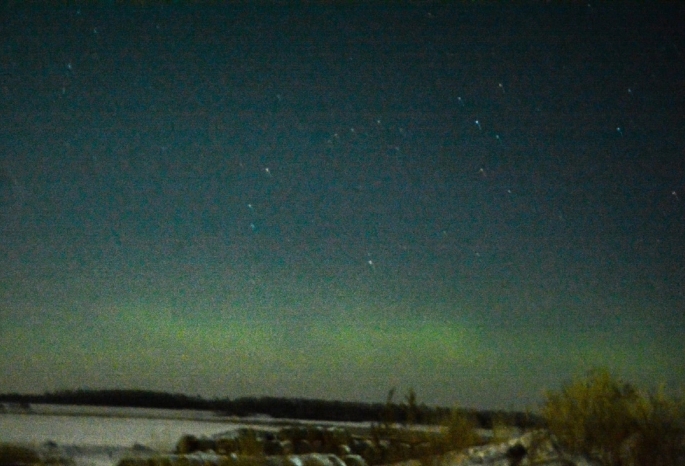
[0, 404, 369, 466]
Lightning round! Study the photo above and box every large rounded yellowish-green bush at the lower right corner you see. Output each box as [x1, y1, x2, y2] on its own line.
[542, 370, 685, 466]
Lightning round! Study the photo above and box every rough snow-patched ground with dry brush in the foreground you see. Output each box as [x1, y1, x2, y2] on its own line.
[166, 427, 685, 466]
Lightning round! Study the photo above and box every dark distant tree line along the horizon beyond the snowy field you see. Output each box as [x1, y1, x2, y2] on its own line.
[0, 389, 537, 428]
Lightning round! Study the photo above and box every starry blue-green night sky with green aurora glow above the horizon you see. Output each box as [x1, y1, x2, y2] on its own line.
[0, 2, 685, 409]
